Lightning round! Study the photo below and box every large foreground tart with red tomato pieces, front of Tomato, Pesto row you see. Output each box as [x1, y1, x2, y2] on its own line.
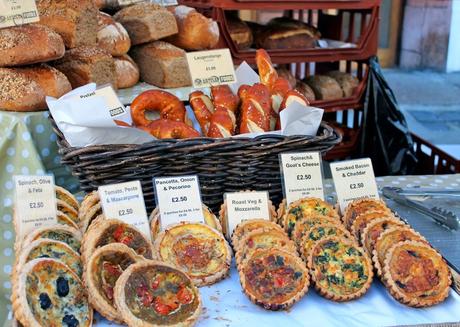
[114, 260, 201, 327]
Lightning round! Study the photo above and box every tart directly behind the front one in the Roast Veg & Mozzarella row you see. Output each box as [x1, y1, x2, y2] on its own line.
[235, 228, 297, 266]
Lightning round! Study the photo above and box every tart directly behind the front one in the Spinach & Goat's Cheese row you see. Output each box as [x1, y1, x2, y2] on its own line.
[299, 223, 353, 262]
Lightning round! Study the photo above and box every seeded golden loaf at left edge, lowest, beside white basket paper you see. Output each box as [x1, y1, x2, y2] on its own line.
[0, 64, 72, 111]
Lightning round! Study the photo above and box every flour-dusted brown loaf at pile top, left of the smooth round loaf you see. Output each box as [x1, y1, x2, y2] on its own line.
[113, 3, 178, 45]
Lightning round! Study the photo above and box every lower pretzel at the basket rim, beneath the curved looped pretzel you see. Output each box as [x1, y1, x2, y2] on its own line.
[140, 119, 200, 139]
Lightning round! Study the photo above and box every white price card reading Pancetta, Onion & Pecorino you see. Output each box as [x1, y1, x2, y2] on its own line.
[153, 175, 205, 229]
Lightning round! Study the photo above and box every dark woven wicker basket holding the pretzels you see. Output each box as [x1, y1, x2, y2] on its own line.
[51, 119, 341, 212]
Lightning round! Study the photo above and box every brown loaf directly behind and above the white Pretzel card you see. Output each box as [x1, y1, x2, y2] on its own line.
[55, 46, 117, 89]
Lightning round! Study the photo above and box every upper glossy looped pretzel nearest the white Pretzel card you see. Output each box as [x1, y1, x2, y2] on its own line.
[131, 90, 185, 126]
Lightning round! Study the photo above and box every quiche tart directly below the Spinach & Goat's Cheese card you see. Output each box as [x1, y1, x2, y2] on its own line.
[282, 198, 339, 236]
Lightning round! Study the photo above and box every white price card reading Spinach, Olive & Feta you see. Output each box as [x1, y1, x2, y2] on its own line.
[13, 175, 57, 236]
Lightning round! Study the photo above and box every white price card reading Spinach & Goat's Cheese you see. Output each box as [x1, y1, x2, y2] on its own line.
[280, 152, 324, 205]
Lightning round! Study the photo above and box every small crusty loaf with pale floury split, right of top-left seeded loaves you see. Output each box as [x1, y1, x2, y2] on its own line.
[97, 12, 131, 56]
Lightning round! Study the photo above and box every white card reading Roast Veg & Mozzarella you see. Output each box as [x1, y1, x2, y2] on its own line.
[224, 191, 270, 237]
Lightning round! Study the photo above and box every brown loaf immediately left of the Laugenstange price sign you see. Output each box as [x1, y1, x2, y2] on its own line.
[130, 41, 192, 88]
